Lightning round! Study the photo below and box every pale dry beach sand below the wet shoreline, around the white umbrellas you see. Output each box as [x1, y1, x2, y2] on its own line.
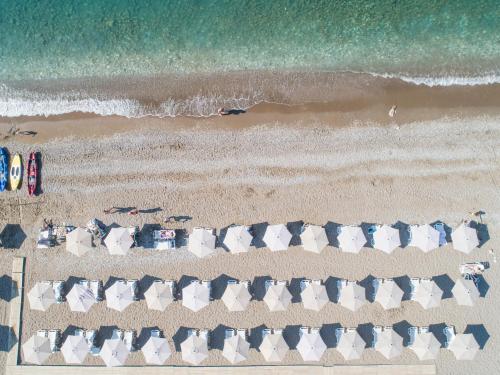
[0, 104, 500, 374]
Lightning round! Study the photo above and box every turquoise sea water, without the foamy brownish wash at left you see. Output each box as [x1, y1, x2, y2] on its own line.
[0, 0, 500, 115]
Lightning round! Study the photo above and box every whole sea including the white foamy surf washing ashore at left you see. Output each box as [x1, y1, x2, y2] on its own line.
[0, 0, 500, 117]
